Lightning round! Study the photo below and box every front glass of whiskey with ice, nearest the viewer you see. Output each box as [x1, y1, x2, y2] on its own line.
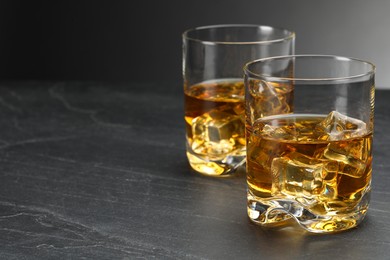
[244, 55, 375, 233]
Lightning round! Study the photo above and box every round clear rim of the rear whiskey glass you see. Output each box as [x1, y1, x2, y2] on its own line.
[182, 24, 295, 45]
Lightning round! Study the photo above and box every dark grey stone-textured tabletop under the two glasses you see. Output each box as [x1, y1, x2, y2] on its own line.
[0, 82, 390, 259]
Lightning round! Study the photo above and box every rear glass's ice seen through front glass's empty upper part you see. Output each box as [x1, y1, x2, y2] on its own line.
[249, 80, 291, 121]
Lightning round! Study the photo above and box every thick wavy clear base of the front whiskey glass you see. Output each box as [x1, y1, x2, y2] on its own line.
[247, 190, 370, 233]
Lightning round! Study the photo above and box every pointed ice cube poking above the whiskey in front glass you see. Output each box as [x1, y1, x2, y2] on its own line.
[316, 111, 367, 141]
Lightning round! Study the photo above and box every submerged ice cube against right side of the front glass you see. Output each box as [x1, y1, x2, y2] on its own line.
[324, 138, 371, 178]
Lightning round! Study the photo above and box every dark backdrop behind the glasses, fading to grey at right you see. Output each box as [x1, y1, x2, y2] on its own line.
[0, 0, 390, 87]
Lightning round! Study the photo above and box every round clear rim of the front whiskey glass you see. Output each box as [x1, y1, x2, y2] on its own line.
[243, 54, 376, 82]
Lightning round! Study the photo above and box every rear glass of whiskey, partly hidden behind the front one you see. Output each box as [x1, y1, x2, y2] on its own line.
[183, 24, 295, 177]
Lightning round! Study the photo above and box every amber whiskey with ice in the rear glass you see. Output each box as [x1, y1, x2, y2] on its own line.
[185, 79, 245, 176]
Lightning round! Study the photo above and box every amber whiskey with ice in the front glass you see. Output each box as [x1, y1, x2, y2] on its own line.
[247, 111, 372, 232]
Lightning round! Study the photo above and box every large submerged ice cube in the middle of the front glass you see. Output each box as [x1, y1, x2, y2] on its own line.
[271, 152, 338, 204]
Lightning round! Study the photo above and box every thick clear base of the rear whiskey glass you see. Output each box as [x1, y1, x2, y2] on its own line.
[187, 150, 245, 177]
